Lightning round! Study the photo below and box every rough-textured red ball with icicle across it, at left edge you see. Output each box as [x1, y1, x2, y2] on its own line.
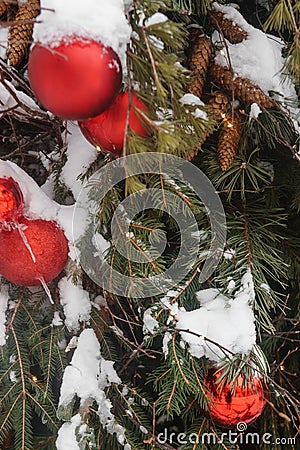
[0, 217, 69, 286]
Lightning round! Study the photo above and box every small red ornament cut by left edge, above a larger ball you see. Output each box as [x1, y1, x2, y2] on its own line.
[0, 177, 24, 225]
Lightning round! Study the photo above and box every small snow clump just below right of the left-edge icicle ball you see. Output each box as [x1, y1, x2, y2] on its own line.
[58, 277, 92, 331]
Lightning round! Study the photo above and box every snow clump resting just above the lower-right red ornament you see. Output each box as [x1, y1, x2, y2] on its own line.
[143, 269, 256, 362]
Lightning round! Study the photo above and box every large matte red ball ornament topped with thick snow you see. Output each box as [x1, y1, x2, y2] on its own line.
[28, 37, 122, 120]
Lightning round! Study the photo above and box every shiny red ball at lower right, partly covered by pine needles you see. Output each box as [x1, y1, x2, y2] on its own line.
[205, 371, 266, 427]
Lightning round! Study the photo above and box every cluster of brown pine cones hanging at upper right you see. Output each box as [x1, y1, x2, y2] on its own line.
[187, 10, 275, 171]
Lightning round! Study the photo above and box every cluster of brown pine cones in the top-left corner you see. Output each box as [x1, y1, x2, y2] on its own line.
[0, 0, 40, 67]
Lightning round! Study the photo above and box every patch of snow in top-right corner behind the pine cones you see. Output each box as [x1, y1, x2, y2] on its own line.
[213, 3, 296, 99]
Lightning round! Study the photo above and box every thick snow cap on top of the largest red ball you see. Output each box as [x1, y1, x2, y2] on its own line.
[33, 0, 131, 66]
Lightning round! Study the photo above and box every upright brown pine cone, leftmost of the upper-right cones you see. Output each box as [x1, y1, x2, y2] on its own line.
[187, 29, 212, 97]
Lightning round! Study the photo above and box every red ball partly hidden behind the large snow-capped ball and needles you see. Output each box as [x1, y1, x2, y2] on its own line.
[79, 92, 148, 156]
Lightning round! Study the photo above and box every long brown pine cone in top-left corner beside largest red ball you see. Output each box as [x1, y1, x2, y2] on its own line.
[7, 0, 40, 66]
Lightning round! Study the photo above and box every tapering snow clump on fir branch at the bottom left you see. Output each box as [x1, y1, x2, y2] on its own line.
[57, 329, 125, 450]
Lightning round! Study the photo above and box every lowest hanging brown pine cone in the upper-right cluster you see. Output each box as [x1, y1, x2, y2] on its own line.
[217, 111, 243, 171]
